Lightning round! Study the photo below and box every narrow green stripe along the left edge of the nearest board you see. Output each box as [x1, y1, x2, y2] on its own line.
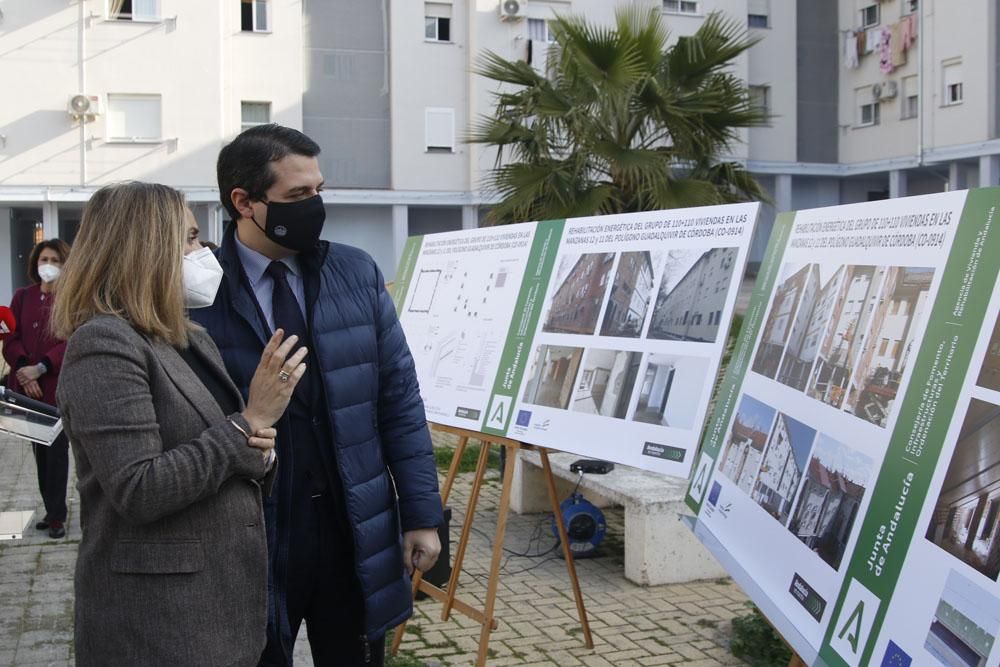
[685, 212, 795, 514]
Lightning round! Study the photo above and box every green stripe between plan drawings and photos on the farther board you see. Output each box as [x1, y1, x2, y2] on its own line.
[482, 220, 566, 435]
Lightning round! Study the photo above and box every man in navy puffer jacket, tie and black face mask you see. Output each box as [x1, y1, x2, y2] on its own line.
[191, 125, 442, 665]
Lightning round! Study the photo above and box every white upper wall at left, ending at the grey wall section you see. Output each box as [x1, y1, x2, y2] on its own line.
[0, 0, 302, 187]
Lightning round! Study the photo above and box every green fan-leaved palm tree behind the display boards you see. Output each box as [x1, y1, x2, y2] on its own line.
[468, 5, 767, 224]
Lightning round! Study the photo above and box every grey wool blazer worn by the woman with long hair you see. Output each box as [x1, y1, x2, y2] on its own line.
[57, 316, 274, 667]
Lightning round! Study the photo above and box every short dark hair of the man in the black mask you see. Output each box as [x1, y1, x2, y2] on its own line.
[216, 123, 319, 220]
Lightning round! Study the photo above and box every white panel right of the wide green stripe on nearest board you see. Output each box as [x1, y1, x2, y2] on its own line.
[873, 270, 1000, 665]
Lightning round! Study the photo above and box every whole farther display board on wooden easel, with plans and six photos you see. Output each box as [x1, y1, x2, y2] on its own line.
[394, 203, 760, 476]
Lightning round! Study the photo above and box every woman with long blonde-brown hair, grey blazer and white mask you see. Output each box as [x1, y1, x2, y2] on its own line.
[53, 182, 305, 666]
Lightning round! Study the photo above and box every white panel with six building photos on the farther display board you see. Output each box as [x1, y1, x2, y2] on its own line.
[508, 205, 756, 475]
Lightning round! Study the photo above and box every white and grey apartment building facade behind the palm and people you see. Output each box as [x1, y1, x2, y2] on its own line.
[0, 0, 1000, 300]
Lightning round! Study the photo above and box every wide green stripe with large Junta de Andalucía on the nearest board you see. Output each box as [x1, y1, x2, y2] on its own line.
[820, 188, 1000, 665]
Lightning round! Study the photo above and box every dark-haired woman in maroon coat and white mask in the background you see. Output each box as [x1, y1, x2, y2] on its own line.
[3, 239, 69, 538]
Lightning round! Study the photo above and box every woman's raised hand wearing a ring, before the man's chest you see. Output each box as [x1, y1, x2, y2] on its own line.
[243, 329, 308, 434]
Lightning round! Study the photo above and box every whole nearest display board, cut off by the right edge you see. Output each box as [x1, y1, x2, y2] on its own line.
[688, 189, 1000, 665]
